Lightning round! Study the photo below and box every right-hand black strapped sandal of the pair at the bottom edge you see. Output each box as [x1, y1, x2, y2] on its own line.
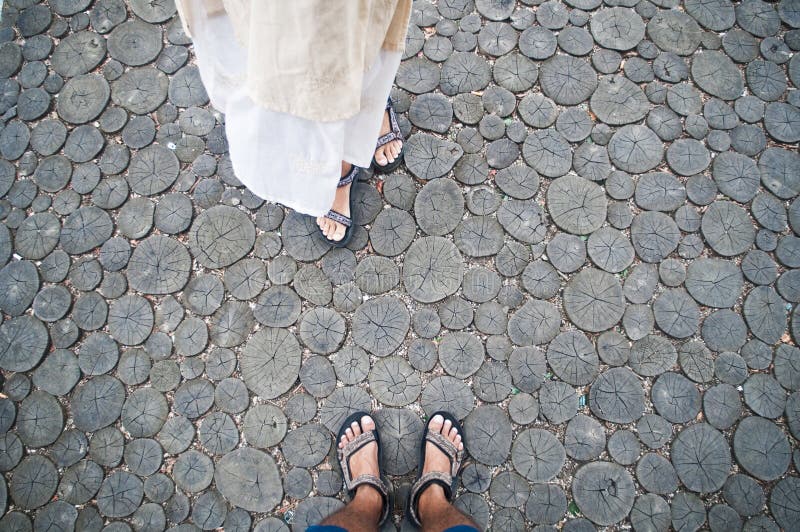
[408, 411, 466, 528]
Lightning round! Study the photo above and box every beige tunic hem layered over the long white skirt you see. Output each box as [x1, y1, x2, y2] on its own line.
[175, 0, 412, 122]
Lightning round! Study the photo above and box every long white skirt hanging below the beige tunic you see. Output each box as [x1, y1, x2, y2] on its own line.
[186, 0, 401, 216]
